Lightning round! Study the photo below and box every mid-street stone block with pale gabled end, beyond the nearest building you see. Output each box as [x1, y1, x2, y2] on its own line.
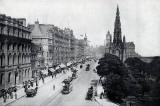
[29, 21, 75, 67]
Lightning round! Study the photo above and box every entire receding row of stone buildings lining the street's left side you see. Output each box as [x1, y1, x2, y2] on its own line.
[0, 14, 87, 89]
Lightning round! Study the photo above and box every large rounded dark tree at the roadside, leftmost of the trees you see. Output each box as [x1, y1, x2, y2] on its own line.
[97, 54, 127, 103]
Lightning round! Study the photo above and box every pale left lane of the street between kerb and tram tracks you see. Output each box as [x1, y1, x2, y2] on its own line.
[6, 72, 71, 106]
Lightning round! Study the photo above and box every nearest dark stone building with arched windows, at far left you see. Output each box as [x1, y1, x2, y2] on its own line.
[0, 14, 32, 89]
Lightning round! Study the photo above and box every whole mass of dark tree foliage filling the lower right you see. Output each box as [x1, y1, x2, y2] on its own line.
[97, 54, 160, 103]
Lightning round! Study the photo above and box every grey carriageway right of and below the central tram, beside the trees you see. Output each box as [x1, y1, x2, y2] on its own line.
[47, 61, 101, 106]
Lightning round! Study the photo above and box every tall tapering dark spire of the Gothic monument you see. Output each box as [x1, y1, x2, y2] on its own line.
[113, 5, 122, 45]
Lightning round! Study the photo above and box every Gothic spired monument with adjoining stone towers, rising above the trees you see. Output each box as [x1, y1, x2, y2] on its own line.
[105, 6, 138, 61]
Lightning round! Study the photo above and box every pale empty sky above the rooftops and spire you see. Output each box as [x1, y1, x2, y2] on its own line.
[0, 0, 160, 56]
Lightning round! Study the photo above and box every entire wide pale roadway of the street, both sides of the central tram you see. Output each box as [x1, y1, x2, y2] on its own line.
[6, 62, 117, 106]
